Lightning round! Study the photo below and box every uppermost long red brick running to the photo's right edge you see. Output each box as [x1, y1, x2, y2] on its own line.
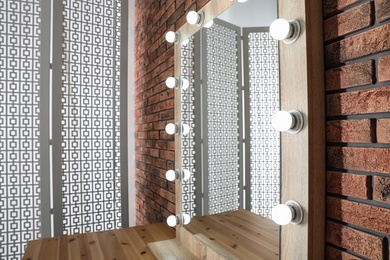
[325, 24, 390, 67]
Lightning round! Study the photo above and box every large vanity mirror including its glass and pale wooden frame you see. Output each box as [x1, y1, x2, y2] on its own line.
[171, 0, 325, 259]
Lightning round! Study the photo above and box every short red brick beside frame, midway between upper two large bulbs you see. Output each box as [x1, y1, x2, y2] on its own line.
[325, 60, 375, 91]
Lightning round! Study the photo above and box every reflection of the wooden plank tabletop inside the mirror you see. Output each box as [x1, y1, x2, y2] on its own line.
[185, 210, 280, 260]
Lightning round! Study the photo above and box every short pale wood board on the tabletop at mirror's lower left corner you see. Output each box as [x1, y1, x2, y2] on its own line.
[148, 239, 199, 260]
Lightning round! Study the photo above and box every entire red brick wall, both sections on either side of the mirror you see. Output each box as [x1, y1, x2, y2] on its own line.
[135, 0, 390, 259]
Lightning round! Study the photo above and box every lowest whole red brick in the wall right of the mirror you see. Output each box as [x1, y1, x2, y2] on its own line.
[326, 221, 384, 259]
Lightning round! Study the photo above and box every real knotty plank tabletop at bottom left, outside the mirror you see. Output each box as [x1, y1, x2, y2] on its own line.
[23, 223, 175, 260]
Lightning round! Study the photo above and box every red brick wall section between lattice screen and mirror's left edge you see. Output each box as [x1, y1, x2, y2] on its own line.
[134, 0, 208, 225]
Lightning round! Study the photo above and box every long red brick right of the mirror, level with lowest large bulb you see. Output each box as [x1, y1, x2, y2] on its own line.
[326, 196, 390, 235]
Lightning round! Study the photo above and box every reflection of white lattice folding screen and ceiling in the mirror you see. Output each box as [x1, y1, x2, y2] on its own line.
[181, 0, 280, 218]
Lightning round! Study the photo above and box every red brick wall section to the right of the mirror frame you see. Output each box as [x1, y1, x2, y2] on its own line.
[323, 0, 390, 259]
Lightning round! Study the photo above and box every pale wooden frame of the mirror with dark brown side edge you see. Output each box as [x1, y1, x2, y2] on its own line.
[175, 0, 325, 259]
